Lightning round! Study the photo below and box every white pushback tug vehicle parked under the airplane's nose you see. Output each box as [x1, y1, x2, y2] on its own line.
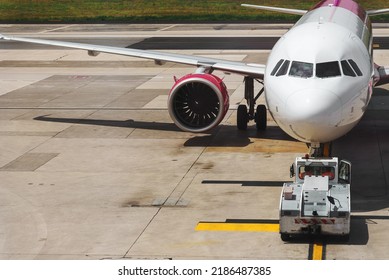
[280, 155, 351, 241]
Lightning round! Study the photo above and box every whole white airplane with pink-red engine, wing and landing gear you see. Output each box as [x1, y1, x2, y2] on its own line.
[0, 0, 389, 156]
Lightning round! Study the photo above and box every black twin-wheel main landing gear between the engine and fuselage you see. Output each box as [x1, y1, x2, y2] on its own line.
[237, 77, 267, 130]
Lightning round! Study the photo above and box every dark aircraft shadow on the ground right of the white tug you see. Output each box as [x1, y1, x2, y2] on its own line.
[332, 88, 389, 212]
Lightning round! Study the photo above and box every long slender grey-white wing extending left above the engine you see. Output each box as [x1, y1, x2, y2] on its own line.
[0, 34, 266, 80]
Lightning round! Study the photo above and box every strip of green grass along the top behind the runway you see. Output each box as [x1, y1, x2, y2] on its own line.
[0, 0, 389, 23]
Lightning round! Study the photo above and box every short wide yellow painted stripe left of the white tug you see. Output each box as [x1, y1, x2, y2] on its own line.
[196, 223, 280, 232]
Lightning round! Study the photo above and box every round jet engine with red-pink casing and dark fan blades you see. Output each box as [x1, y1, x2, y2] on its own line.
[168, 74, 229, 132]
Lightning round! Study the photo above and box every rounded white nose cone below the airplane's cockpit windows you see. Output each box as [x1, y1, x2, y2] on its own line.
[286, 89, 342, 143]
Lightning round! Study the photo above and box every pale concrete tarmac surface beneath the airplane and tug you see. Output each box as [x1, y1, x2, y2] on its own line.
[0, 24, 389, 260]
